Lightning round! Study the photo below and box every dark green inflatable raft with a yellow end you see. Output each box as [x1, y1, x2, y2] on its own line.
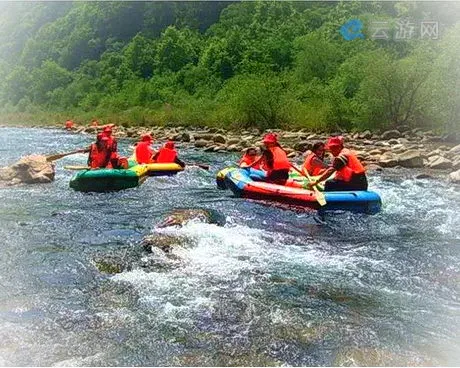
[70, 165, 147, 192]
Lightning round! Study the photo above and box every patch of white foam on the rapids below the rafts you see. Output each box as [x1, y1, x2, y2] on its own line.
[113, 222, 394, 322]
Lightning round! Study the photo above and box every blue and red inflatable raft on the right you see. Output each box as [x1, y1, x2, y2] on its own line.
[216, 168, 382, 214]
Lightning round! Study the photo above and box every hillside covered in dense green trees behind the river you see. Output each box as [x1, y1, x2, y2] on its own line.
[0, 1, 460, 131]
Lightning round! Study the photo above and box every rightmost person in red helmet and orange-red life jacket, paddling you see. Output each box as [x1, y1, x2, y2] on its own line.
[309, 137, 368, 192]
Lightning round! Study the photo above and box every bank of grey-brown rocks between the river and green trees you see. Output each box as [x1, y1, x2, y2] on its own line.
[63, 125, 460, 183]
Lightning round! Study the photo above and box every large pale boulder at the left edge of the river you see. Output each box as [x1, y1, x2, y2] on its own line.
[0, 155, 55, 185]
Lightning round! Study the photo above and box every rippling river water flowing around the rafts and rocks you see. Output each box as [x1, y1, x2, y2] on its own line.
[0, 128, 460, 366]
